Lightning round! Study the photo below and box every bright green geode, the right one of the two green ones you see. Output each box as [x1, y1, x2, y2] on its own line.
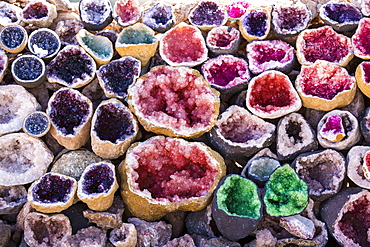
[263, 164, 308, 216]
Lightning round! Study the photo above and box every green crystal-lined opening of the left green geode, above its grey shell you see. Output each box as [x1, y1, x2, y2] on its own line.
[217, 175, 261, 219]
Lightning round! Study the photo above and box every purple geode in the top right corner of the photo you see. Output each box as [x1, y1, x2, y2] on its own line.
[324, 3, 362, 24]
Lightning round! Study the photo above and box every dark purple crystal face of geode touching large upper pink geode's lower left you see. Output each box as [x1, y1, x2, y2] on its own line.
[94, 104, 134, 143]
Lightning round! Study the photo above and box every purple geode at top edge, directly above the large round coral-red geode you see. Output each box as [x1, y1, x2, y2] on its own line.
[189, 1, 225, 26]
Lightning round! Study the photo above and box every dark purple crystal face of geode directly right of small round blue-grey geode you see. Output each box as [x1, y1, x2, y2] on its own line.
[50, 90, 89, 135]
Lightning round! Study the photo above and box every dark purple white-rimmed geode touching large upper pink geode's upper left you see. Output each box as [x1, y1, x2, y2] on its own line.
[96, 56, 141, 99]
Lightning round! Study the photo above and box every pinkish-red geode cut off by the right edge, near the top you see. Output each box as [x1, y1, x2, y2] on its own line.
[351, 18, 370, 60]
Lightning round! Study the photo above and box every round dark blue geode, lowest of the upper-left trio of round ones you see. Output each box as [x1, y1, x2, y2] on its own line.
[11, 55, 46, 88]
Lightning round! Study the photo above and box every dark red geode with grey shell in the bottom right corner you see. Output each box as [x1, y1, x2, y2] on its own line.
[320, 187, 370, 246]
